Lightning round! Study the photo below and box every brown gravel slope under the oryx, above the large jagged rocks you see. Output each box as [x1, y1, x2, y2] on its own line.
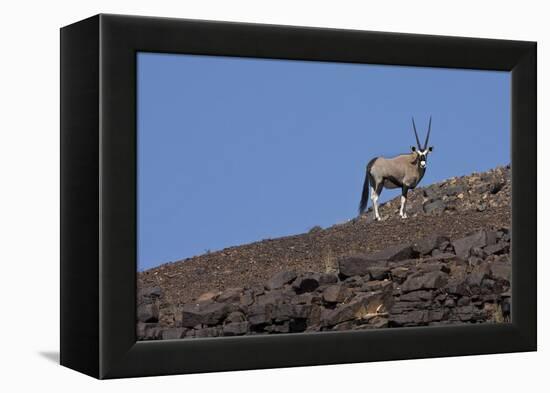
[137, 162, 511, 314]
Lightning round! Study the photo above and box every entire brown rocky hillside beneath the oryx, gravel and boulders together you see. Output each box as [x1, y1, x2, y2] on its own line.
[138, 167, 511, 339]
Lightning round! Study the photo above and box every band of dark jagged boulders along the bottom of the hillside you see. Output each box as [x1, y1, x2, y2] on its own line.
[138, 228, 511, 340]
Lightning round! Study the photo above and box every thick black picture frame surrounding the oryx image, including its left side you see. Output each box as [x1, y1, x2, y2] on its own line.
[61, 14, 537, 379]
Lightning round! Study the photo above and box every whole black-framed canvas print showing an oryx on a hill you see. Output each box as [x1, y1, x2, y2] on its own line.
[61, 15, 537, 378]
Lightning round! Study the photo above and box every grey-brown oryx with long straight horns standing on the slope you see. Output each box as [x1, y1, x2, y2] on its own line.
[359, 116, 433, 220]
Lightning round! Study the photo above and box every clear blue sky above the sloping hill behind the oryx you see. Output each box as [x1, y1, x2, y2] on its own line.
[137, 53, 510, 270]
